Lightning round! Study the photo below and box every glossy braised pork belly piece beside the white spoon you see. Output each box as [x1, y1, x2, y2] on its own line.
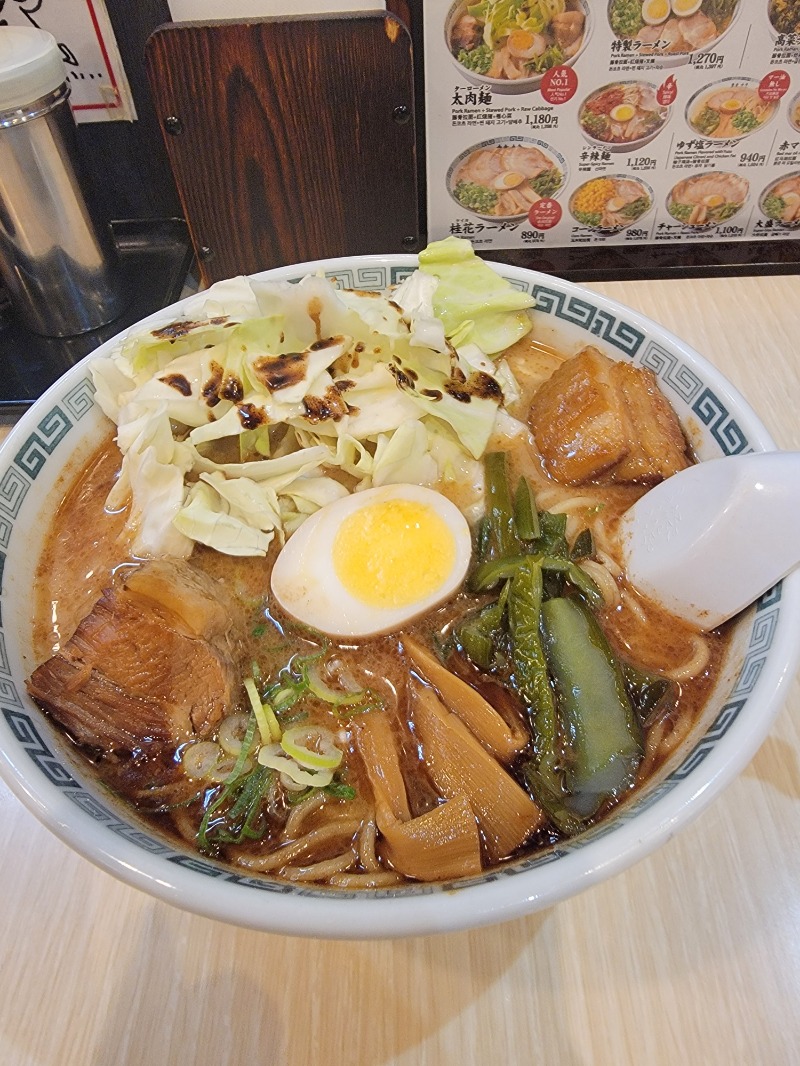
[528, 346, 689, 485]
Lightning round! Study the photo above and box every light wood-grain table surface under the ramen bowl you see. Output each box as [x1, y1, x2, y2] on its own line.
[0, 276, 800, 1066]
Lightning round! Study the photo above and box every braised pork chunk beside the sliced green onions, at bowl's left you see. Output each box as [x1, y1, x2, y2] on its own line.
[28, 560, 236, 752]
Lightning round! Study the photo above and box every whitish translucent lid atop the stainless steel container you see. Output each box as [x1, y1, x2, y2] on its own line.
[0, 26, 66, 111]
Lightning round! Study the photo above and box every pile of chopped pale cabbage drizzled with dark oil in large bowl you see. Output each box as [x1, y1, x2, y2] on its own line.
[91, 238, 532, 558]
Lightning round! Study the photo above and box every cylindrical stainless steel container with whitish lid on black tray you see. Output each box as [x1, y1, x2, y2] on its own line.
[0, 27, 126, 337]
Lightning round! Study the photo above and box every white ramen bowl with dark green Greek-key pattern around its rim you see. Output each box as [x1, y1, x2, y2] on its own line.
[0, 256, 800, 938]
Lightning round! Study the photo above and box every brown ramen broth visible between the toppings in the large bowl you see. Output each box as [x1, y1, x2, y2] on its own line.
[25, 328, 737, 889]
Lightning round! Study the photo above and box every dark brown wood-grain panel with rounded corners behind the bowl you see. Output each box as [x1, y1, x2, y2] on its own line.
[146, 13, 419, 281]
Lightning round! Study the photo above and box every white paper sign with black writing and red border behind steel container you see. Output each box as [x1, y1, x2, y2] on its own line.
[0, 0, 137, 123]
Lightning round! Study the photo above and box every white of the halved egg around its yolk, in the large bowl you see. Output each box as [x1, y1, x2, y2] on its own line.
[271, 485, 471, 639]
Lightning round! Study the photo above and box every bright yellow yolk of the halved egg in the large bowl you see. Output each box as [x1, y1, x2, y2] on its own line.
[333, 500, 455, 608]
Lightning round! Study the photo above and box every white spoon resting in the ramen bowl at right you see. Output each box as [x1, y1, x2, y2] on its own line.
[620, 452, 800, 630]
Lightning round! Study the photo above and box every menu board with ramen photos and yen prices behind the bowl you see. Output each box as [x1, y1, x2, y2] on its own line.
[425, 0, 800, 249]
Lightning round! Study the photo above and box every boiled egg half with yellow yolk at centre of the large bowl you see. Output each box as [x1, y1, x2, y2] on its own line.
[272, 485, 471, 639]
